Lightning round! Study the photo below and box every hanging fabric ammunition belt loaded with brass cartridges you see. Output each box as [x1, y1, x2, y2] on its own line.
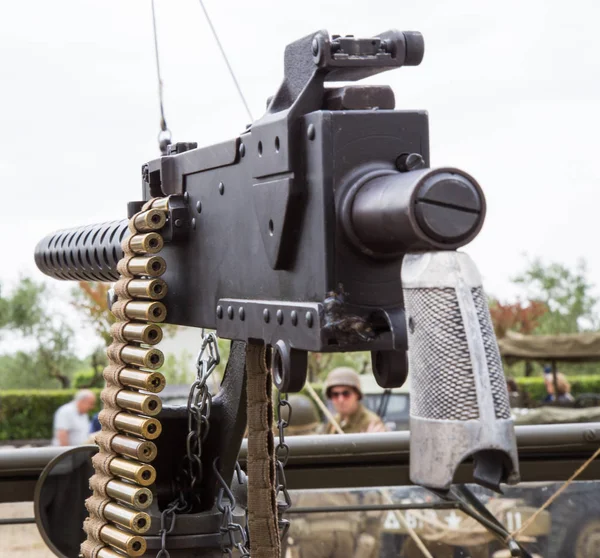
[81, 198, 168, 558]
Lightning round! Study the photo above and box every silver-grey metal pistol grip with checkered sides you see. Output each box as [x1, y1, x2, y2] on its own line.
[402, 252, 519, 490]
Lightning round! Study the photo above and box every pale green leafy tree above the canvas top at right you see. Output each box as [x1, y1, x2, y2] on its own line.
[513, 259, 600, 334]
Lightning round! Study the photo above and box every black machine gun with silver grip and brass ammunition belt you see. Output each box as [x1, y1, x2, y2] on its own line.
[35, 31, 518, 558]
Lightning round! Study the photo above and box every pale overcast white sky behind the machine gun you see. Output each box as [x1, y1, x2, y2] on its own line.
[0, 0, 600, 356]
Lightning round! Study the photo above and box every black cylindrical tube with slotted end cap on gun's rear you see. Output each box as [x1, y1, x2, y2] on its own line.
[340, 168, 486, 256]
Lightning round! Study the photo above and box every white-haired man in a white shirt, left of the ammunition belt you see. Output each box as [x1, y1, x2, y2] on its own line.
[52, 389, 96, 446]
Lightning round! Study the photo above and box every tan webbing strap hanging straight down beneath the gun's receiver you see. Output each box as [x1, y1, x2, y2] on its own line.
[246, 342, 281, 558]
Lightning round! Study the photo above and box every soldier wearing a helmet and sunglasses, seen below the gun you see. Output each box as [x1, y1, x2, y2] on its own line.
[325, 366, 386, 434]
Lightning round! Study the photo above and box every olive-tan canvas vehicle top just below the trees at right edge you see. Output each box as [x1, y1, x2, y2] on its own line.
[498, 331, 600, 362]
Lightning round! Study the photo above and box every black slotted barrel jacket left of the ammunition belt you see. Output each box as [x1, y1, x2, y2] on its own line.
[35, 219, 130, 282]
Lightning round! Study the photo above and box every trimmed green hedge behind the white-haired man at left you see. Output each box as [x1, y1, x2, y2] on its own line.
[0, 389, 100, 440]
